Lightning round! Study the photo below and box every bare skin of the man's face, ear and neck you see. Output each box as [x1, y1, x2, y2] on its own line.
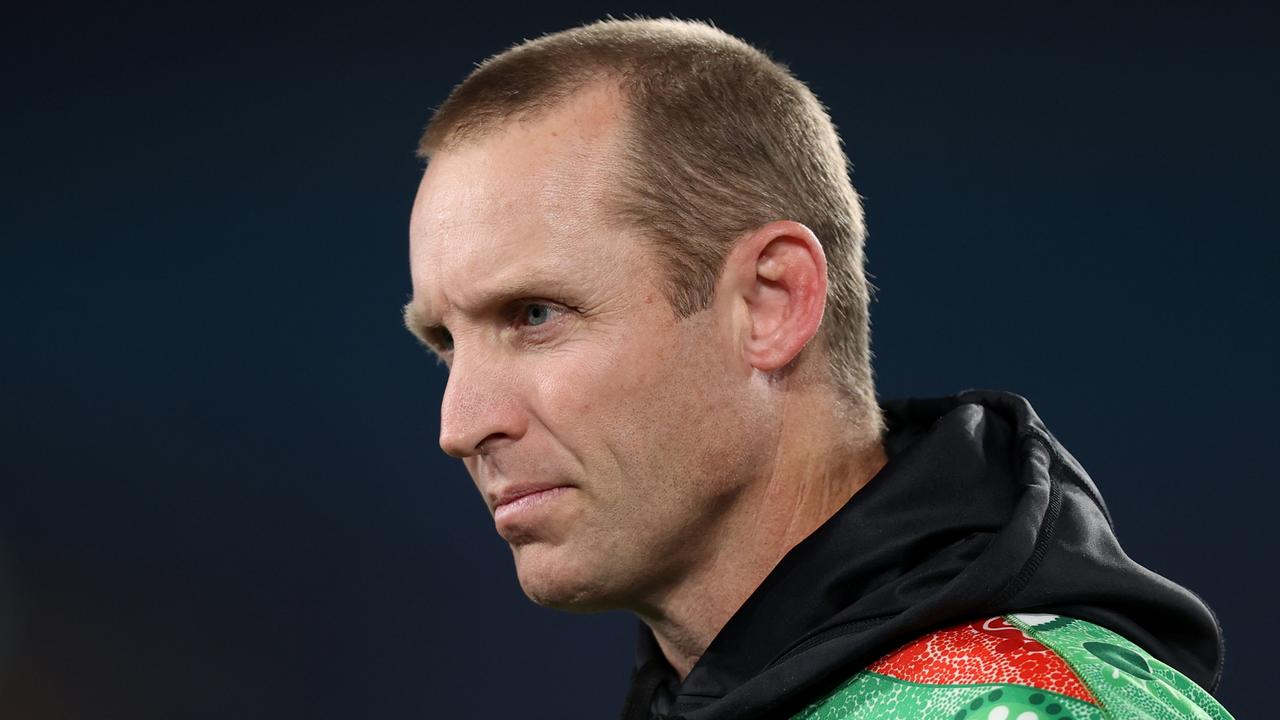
[407, 87, 883, 676]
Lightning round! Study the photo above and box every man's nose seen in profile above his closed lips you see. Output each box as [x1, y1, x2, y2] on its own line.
[440, 354, 525, 459]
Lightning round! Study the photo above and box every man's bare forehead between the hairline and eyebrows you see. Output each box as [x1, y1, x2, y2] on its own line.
[410, 83, 632, 311]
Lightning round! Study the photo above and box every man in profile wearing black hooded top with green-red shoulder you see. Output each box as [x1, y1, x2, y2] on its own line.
[406, 20, 1228, 720]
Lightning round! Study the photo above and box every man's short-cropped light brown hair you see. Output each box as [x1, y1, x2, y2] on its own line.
[419, 19, 876, 409]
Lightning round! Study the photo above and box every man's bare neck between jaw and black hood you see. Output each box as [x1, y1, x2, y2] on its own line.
[636, 386, 886, 680]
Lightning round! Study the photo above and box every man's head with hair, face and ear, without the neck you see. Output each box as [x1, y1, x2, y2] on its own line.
[407, 20, 879, 609]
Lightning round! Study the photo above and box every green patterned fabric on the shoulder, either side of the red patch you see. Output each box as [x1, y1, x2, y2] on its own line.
[792, 615, 1231, 720]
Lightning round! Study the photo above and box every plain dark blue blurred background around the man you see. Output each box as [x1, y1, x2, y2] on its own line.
[0, 3, 1280, 720]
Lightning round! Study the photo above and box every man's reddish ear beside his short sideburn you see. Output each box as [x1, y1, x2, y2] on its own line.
[723, 220, 827, 373]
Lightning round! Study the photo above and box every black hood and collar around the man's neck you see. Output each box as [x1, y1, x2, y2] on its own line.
[623, 391, 1222, 720]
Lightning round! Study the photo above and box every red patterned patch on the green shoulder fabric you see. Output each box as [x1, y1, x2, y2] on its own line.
[868, 618, 1096, 702]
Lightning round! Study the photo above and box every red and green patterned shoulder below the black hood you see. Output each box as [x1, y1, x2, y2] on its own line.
[794, 614, 1231, 720]
